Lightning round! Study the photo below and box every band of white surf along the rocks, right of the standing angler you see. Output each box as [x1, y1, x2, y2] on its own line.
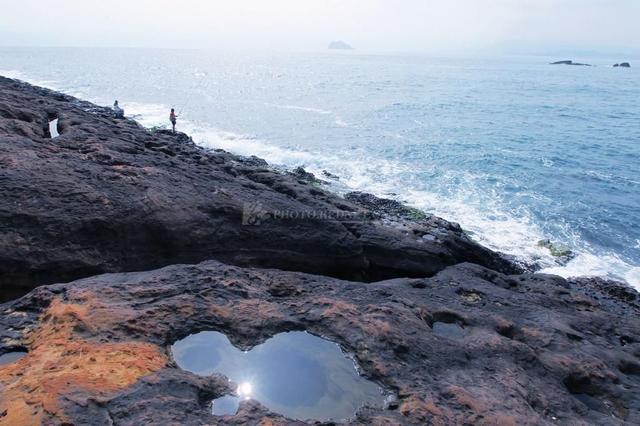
[180, 118, 640, 289]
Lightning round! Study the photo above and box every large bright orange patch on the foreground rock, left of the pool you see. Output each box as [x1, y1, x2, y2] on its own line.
[0, 300, 167, 425]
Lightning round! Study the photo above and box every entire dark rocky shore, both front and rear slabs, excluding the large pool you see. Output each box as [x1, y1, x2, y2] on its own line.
[0, 78, 640, 425]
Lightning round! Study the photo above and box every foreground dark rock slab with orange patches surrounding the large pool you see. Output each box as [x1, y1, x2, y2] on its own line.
[0, 261, 640, 426]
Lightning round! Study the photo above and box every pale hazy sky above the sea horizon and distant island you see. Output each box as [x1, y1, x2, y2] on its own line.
[0, 0, 640, 53]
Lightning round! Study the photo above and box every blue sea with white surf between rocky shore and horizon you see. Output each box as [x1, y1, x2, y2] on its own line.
[0, 48, 640, 288]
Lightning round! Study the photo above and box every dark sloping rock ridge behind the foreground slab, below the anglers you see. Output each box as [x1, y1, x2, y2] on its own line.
[0, 78, 514, 300]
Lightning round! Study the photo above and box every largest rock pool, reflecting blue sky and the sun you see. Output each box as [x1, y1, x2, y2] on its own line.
[172, 331, 385, 421]
